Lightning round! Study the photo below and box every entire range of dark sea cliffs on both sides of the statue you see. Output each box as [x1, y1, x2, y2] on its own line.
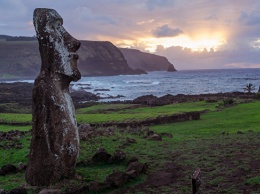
[0, 36, 176, 79]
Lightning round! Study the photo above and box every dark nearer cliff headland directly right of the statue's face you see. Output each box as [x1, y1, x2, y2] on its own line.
[78, 41, 144, 76]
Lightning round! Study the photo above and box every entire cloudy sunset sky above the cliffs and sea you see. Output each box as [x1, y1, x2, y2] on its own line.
[0, 0, 260, 70]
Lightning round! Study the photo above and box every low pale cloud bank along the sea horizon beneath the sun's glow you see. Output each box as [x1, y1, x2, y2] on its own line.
[156, 45, 260, 70]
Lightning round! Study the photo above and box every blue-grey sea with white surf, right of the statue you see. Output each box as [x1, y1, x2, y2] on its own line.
[72, 69, 260, 101]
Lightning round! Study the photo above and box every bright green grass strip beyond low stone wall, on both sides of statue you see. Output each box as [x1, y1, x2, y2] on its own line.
[0, 102, 217, 124]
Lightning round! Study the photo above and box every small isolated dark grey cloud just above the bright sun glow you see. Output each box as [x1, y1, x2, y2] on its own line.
[152, 25, 183, 38]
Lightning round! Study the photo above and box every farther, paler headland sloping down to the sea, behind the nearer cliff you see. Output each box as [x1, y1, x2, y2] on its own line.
[120, 48, 176, 71]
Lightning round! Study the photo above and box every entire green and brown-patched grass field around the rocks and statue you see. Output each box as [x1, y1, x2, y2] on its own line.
[0, 101, 260, 194]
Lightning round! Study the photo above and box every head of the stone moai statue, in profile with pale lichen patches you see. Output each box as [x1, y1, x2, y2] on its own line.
[33, 8, 81, 81]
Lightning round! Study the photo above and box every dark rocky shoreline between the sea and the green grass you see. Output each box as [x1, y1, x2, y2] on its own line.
[0, 82, 255, 112]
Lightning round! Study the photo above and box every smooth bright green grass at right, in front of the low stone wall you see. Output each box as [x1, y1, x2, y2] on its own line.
[151, 101, 260, 141]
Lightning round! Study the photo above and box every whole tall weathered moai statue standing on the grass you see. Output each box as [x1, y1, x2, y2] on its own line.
[25, 8, 81, 186]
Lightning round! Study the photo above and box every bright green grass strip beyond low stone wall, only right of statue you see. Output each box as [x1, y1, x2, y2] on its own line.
[77, 101, 218, 124]
